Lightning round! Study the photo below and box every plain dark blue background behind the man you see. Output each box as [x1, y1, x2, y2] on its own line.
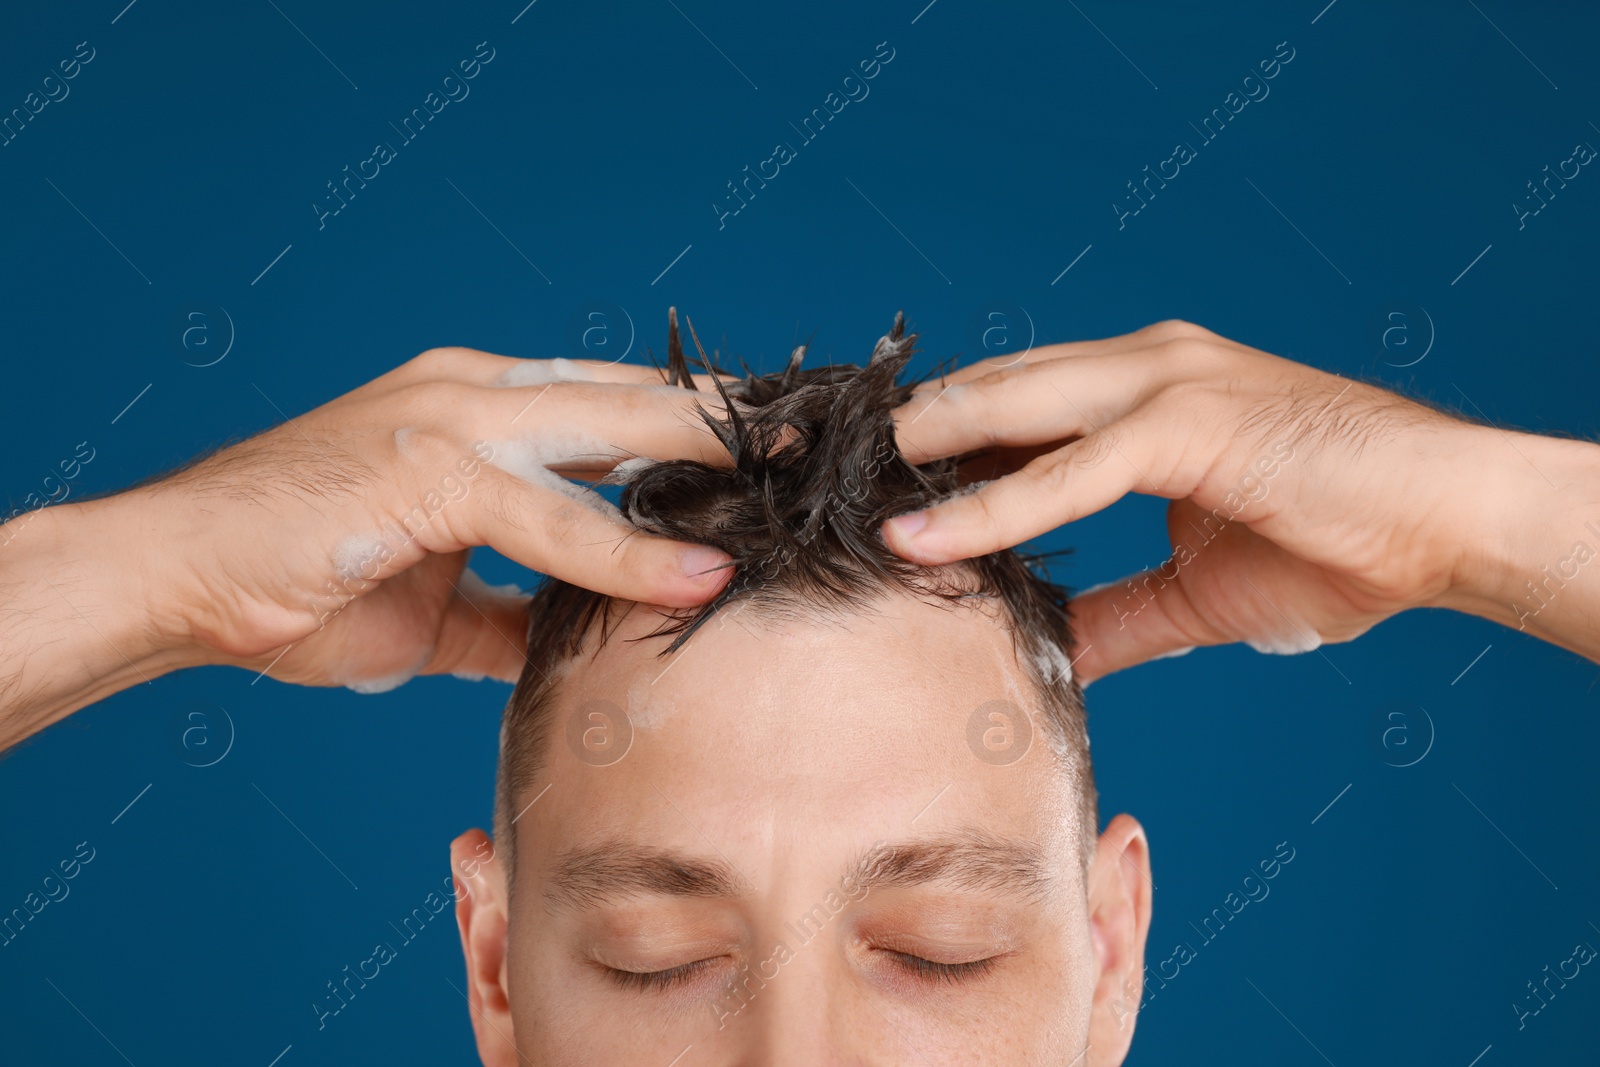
[0, 0, 1600, 1067]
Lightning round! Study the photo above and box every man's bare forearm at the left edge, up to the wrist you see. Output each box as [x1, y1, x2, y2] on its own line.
[0, 498, 196, 750]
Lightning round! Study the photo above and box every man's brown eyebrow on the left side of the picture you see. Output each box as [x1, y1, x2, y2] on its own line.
[544, 841, 741, 907]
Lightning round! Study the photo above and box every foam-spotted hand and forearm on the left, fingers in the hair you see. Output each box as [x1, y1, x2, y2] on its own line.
[0, 349, 728, 749]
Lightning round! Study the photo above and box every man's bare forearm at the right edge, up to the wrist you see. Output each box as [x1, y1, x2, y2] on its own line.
[1438, 427, 1600, 661]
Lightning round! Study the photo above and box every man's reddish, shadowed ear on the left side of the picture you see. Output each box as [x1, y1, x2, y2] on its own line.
[450, 830, 518, 1067]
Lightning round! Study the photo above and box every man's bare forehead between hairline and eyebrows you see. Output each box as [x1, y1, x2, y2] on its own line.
[514, 597, 1075, 876]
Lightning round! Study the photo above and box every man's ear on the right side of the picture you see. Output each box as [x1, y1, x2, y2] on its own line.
[1088, 814, 1154, 1067]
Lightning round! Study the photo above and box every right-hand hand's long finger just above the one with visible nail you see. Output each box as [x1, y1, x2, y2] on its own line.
[894, 350, 1178, 464]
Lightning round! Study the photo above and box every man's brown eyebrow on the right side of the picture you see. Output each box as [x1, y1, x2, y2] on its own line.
[845, 829, 1054, 897]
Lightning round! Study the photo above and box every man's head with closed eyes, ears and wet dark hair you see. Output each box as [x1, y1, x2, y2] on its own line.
[454, 318, 1149, 1064]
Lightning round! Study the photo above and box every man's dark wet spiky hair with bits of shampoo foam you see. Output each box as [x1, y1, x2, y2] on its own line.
[496, 309, 1098, 862]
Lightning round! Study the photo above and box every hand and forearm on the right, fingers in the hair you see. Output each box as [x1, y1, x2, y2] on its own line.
[883, 322, 1600, 681]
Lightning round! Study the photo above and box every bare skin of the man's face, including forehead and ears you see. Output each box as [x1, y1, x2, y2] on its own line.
[451, 593, 1150, 1067]
